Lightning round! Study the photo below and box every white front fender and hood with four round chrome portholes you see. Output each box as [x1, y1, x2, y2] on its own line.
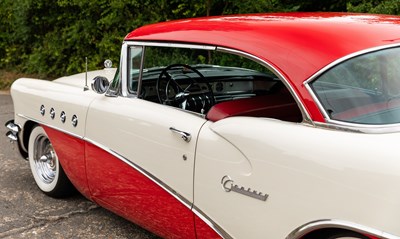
[11, 69, 116, 148]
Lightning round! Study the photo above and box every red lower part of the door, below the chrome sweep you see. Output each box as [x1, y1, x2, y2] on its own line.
[86, 143, 196, 238]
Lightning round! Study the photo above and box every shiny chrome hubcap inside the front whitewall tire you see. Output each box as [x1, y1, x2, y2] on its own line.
[33, 135, 57, 184]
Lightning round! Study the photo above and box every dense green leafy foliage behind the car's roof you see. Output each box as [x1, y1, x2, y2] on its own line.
[0, 0, 400, 77]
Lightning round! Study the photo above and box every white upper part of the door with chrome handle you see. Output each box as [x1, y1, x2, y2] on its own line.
[86, 96, 206, 203]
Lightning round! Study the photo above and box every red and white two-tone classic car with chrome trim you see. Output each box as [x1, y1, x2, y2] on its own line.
[6, 13, 400, 239]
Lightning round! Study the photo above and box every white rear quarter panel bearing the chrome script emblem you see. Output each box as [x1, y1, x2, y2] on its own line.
[195, 117, 400, 238]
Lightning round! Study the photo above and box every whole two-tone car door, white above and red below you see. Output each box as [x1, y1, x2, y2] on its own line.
[86, 95, 206, 238]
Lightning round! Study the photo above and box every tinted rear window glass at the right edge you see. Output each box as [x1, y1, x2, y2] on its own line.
[311, 47, 400, 125]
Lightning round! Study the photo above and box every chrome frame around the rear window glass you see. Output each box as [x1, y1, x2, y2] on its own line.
[303, 43, 400, 134]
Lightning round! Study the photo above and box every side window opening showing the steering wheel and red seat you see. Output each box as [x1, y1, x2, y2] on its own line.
[130, 46, 302, 122]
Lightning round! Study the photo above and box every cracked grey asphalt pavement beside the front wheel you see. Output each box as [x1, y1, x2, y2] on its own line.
[0, 92, 157, 239]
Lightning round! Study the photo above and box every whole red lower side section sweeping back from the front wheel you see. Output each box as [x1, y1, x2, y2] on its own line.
[43, 126, 220, 238]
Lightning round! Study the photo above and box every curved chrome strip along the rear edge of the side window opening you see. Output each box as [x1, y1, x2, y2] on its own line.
[217, 47, 314, 125]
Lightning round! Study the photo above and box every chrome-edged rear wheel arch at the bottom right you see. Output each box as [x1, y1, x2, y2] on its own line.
[286, 219, 392, 239]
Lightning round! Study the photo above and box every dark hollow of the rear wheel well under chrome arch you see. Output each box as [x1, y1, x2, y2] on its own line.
[301, 228, 373, 239]
